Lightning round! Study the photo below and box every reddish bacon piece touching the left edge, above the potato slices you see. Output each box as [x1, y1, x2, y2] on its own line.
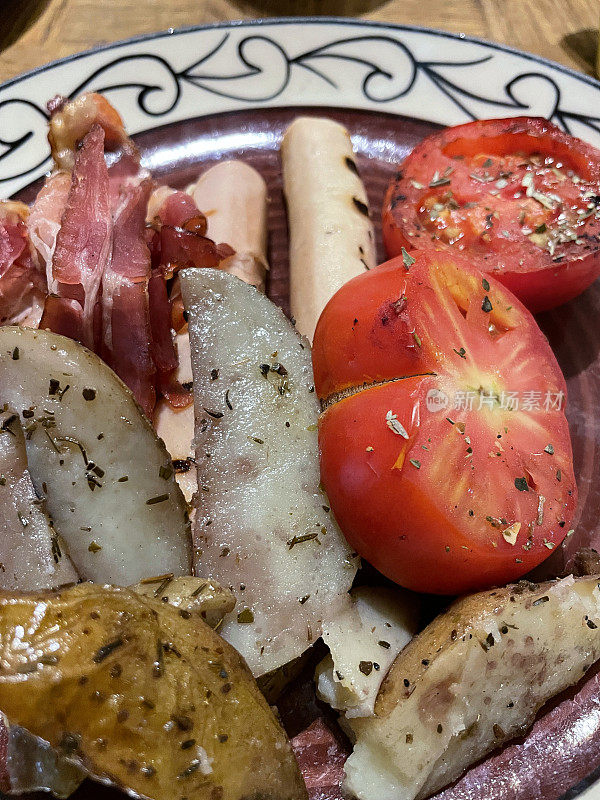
[0, 201, 46, 325]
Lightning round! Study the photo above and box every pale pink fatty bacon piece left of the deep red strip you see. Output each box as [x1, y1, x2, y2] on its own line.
[27, 172, 71, 292]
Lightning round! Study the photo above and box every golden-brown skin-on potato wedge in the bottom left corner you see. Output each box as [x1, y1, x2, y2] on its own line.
[0, 583, 306, 800]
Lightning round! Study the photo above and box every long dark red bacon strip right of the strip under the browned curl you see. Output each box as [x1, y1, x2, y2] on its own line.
[101, 180, 156, 417]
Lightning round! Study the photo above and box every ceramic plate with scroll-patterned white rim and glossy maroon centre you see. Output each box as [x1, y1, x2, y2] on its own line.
[0, 19, 600, 800]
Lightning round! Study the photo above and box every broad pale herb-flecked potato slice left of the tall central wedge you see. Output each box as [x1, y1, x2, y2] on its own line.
[0, 327, 191, 584]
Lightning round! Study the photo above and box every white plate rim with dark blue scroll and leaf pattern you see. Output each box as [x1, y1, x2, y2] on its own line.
[0, 17, 600, 197]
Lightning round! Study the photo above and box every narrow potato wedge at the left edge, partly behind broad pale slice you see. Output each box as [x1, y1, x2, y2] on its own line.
[0, 409, 79, 590]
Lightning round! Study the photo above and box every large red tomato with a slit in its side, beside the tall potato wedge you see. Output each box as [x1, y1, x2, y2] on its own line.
[313, 253, 577, 594]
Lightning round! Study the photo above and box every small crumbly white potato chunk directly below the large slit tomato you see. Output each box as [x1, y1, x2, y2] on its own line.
[315, 586, 420, 717]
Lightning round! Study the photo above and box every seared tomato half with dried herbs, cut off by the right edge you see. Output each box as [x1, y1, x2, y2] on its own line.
[383, 117, 600, 312]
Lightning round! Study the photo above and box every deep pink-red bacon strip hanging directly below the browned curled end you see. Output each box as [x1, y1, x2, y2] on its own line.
[52, 124, 113, 348]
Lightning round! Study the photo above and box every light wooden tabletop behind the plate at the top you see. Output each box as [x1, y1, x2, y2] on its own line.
[0, 0, 600, 81]
